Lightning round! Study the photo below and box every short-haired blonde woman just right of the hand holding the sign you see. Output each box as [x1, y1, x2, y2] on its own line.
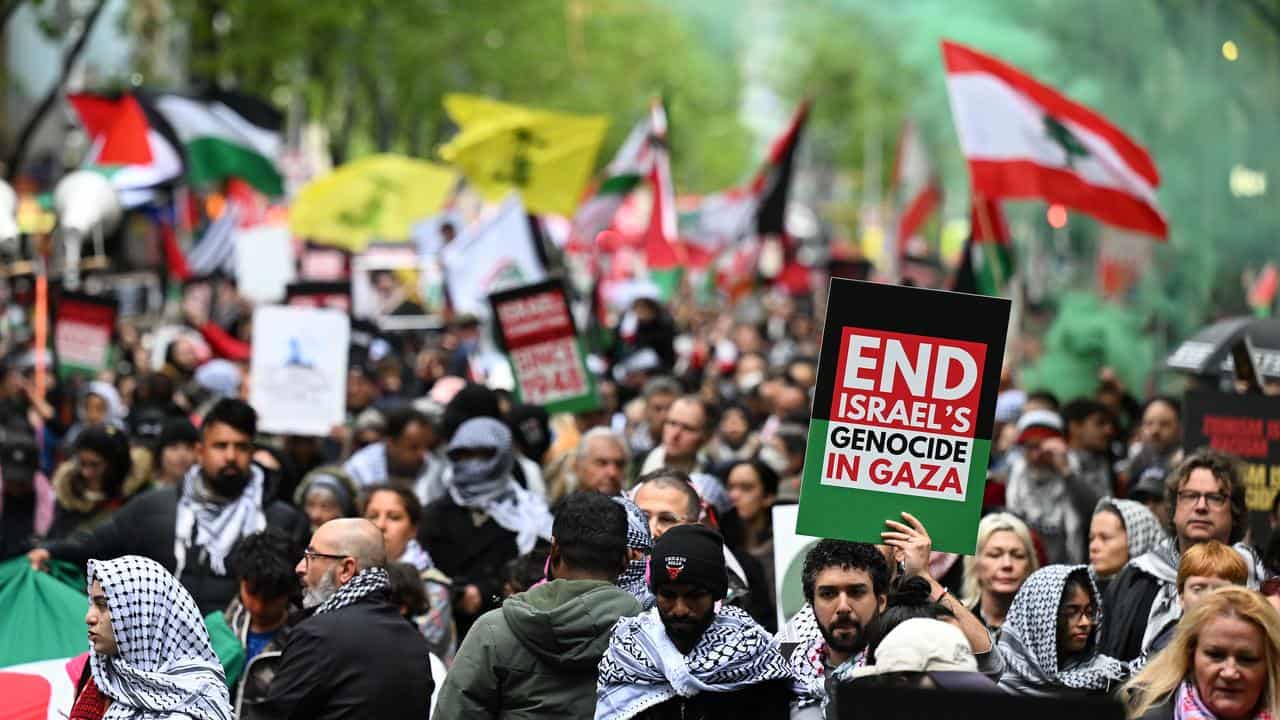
[961, 512, 1039, 633]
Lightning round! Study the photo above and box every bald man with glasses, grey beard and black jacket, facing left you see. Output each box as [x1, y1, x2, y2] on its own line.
[253, 518, 435, 720]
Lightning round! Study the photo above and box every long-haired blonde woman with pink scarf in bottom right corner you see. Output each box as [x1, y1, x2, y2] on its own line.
[1126, 585, 1280, 720]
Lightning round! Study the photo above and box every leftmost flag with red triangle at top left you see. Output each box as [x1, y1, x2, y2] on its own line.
[67, 92, 183, 208]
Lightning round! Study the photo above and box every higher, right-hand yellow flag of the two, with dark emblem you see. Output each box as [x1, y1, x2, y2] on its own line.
[440, 95, 609, 217]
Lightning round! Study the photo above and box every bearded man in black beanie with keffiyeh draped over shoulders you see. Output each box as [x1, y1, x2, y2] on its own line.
[595, 525, 804, 720]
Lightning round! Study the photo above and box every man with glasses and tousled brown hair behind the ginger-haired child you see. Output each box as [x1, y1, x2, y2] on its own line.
[1098, 448, 1263, 661]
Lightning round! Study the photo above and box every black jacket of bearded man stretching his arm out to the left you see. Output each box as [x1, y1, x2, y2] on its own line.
[45, 487, 310, 615]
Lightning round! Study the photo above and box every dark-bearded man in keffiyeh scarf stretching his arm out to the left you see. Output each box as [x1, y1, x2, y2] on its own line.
[27, 398, 307, 615]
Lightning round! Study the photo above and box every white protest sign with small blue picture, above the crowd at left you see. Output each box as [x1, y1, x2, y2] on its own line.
[250, 305, 351, 436]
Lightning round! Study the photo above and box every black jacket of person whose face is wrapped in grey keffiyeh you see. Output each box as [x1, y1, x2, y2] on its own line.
[417, 496, 520, 627]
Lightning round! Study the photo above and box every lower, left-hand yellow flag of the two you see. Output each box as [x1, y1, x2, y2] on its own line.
[289, 155, 457, 252]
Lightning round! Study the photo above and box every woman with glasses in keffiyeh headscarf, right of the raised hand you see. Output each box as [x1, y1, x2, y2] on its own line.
[997, 565, 1132, 697]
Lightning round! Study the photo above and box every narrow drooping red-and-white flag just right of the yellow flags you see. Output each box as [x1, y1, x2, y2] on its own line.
[644, 101, 685, 301]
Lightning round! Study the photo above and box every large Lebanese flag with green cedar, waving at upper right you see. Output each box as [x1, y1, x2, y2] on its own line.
[942, 40, 1169, 240]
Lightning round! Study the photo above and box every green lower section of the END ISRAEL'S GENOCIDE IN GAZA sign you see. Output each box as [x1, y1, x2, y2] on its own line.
[796, 419, 991, 555]
